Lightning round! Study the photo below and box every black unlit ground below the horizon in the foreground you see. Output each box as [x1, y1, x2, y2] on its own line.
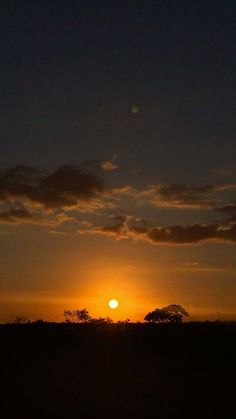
[0, 323, 236, 419]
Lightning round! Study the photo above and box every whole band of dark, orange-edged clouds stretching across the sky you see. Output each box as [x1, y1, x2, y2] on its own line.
[0, 160, 236, 245]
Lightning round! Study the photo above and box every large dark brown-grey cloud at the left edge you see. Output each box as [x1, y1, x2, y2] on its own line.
[0, 166, 106, 208]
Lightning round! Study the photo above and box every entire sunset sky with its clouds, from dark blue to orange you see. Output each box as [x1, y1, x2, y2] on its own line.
[0, 0, 236, 322]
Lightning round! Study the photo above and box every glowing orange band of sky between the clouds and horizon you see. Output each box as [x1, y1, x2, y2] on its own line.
[0, 226, 236, 321]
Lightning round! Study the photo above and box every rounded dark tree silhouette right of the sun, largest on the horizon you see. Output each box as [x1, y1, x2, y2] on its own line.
[144, 304, 189, 323]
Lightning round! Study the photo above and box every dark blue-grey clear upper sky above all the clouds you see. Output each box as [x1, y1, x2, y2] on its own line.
[0, 0, 236, 181]
